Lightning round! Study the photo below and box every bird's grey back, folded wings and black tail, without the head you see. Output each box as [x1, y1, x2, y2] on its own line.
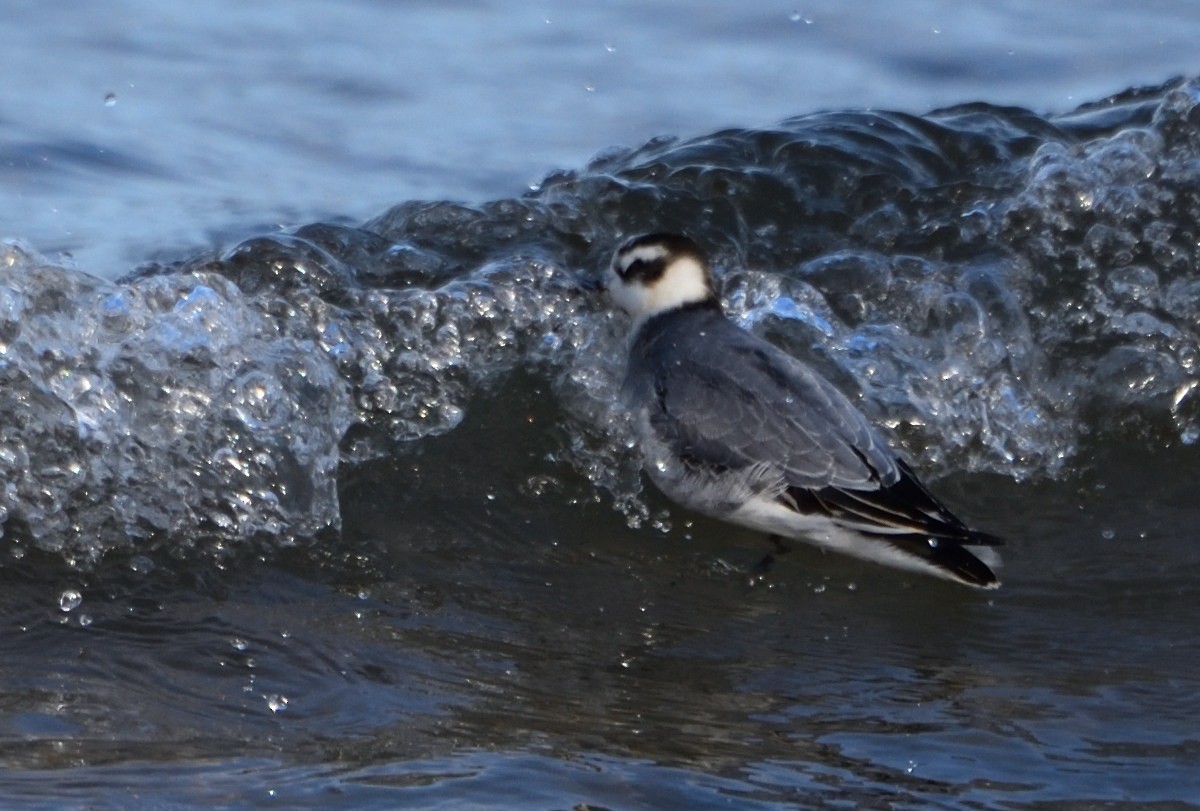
[625, 306, 1002, 588]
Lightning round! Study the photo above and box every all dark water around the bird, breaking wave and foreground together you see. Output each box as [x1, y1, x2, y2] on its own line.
[0, 4, 1200, 809]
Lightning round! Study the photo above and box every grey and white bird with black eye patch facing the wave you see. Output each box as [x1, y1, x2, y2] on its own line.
[601, 233, 1003, 589]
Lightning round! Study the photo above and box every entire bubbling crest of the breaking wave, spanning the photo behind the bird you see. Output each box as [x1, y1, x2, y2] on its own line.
[0, 80, 1200, 565]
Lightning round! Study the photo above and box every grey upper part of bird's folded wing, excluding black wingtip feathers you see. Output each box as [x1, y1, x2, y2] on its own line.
[640, 319, 900, 491]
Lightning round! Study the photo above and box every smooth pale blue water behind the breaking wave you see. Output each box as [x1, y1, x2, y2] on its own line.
[7, 0, 1200, 278]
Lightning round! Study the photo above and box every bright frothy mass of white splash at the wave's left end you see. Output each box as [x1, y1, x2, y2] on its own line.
[0, 245, 352, 563]
